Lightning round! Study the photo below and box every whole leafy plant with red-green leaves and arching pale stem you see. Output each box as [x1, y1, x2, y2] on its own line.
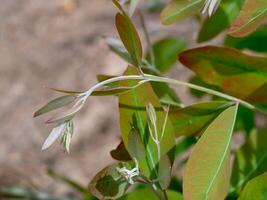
[34, 0, 267, 200]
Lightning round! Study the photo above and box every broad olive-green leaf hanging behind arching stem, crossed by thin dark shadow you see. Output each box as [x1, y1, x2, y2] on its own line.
[119, 67, 175, 179]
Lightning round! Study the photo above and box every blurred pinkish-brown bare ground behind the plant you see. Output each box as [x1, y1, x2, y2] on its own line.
[0, 0, 203, 196]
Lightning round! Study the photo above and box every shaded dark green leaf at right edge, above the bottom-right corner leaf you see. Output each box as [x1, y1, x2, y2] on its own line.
[231, 129, 267, 193]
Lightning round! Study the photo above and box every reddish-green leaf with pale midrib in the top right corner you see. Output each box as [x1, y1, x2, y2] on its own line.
[229, 0, 267, 37]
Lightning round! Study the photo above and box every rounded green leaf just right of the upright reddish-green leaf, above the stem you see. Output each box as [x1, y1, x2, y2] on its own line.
[146, 37, 186, 73]
